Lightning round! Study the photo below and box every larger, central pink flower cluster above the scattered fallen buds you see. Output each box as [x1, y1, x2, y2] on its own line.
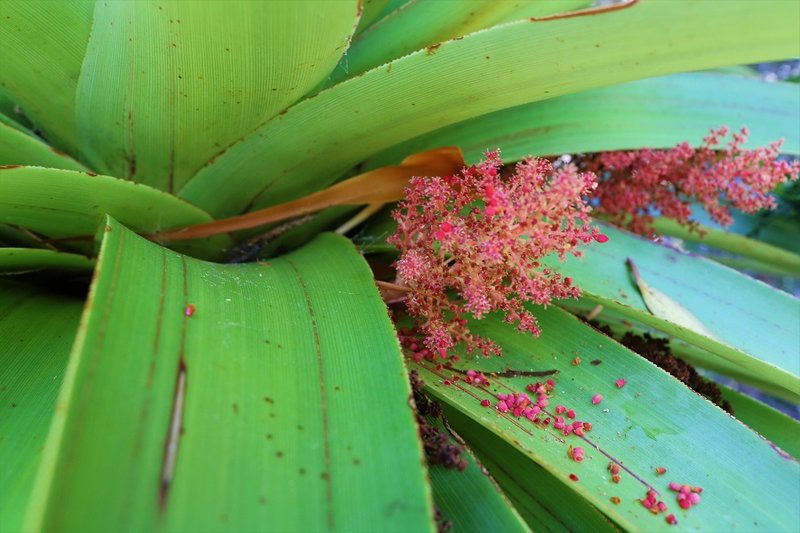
[389, 151, 607, 357]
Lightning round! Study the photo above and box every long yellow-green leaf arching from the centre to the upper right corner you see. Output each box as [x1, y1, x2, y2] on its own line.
[180, 0, 800, 217]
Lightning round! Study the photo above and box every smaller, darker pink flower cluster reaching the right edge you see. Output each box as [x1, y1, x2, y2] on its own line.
[586, 127, 800, 235]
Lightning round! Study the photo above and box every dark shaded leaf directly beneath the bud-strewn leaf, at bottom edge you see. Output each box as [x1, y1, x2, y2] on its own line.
[446, 408, 619, 532]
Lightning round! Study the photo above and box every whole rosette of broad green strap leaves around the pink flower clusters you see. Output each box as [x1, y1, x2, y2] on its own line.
[0, 0, 800, 531]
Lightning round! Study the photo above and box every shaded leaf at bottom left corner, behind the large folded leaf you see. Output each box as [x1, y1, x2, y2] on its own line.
[0, 280, 83, 531]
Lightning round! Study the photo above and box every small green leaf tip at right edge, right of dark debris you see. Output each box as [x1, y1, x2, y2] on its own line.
[720, 385, 800, 459]
